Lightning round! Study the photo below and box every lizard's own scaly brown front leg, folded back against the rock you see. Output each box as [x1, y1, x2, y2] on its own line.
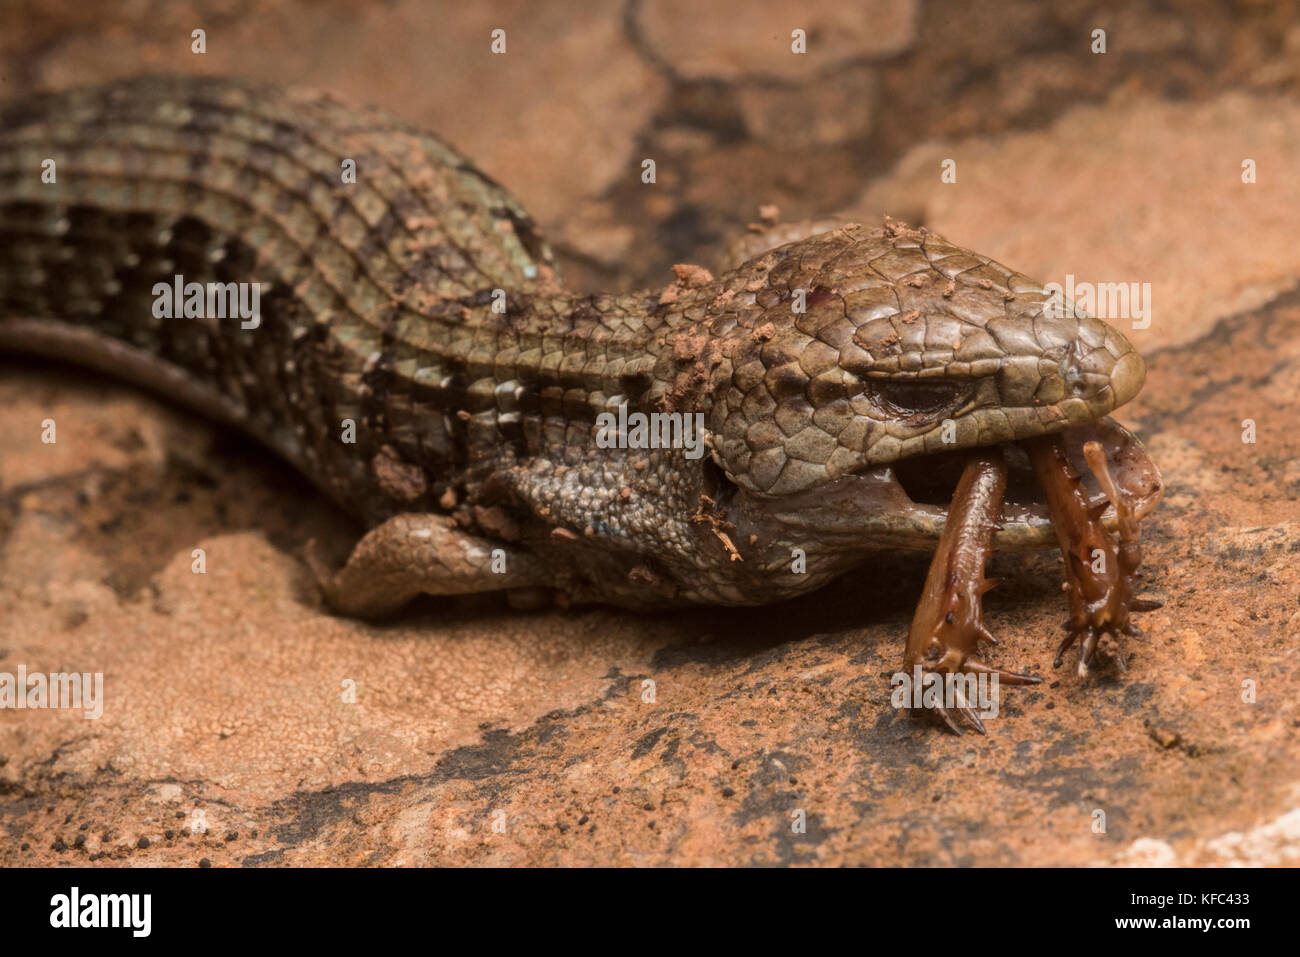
[308, 514, 547, 618]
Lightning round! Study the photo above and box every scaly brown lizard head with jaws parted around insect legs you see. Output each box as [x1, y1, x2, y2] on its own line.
[707, 222, 1158, 547]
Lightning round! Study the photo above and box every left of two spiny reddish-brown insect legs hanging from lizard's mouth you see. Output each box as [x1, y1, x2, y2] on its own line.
[904, 449, 1041, 733]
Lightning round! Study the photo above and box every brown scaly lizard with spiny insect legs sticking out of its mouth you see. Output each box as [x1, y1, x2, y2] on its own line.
[0, 77, 1162, 729]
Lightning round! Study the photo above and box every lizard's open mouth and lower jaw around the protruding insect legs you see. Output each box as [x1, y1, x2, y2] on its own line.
[883, 417, 1165, 549]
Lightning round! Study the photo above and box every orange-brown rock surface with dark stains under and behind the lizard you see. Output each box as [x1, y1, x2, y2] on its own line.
[0, 0, 1300, 866]
